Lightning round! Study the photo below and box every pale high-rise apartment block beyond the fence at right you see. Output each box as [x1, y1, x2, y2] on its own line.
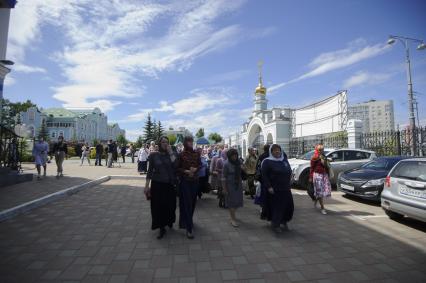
[348, 100, 395, 133]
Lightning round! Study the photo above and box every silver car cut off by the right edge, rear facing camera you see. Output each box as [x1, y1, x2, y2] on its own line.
[381, 158, 426, 222]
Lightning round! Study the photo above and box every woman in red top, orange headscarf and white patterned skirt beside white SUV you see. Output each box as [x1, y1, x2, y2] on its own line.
[309, 144, 331, 215]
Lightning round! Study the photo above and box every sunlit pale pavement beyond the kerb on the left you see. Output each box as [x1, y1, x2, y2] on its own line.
[0, 158, 138, 211]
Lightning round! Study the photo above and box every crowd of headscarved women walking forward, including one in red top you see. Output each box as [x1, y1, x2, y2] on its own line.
[140, 137, 331, 239]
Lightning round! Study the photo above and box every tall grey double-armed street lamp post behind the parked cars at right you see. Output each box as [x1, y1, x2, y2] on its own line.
[388, 35, 426, 156]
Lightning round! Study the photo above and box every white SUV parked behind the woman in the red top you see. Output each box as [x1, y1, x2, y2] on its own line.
[289, 148, 376, 188]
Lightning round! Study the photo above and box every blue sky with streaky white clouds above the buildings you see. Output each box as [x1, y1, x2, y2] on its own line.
[4, 0, 426, 140]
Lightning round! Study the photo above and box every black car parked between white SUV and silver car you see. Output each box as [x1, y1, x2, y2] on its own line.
[337, 156, 407, 202]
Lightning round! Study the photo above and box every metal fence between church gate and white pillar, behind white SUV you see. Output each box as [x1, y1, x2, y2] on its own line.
[287, 132, 348, 158]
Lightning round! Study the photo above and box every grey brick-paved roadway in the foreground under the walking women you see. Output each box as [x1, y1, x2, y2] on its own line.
[0, 180, 426, 283]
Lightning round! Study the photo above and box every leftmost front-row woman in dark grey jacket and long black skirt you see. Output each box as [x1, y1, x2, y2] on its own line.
[144, 137, 177, 239]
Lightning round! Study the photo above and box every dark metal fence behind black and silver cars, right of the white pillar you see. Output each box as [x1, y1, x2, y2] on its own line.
[360, 127, 426, 156]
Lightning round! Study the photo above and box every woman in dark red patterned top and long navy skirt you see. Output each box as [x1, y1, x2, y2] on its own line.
[177, 137, 201, 239]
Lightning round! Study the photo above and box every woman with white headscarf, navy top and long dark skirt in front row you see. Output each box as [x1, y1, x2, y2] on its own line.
[261, 144, 294, 233]
